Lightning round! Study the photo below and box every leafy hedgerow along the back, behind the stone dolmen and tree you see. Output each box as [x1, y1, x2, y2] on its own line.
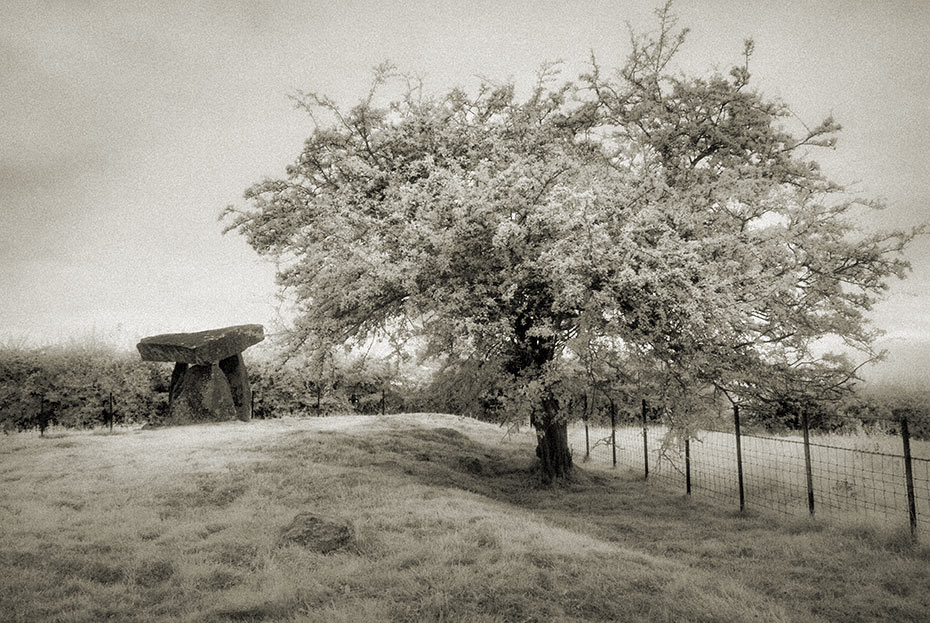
[0, 343, 930, 438]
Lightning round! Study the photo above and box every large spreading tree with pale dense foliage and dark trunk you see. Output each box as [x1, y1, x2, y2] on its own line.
[225, 5, 910, 481]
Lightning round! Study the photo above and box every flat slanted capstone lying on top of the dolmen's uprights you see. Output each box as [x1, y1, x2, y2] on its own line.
[136, 324, 265, 365]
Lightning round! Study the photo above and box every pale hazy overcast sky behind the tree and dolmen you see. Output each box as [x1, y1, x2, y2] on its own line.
[0, 0, 930, 382]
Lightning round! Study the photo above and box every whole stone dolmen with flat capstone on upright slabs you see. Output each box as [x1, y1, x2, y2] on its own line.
[136, 324, 265, 424]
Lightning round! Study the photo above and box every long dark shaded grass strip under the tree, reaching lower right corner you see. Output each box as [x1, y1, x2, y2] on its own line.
[280, 422, 930, 620]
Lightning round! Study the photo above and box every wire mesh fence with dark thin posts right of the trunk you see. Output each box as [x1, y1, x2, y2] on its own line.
[569, 410, 930, 534]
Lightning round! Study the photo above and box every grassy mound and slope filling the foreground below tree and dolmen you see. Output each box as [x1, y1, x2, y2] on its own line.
[0, 415, 930, 621]
